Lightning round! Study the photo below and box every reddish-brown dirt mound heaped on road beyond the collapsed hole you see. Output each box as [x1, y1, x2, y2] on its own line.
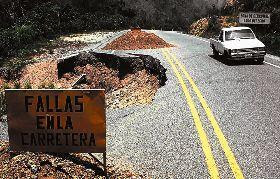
[103, 30, 174, 50]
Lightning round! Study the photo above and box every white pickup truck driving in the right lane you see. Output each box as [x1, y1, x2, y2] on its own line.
[210, 27, 266, 63]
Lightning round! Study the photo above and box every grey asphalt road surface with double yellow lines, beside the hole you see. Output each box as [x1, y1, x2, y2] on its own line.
[104, 31, 280, 179]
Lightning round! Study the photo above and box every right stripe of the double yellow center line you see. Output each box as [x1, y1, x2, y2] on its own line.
[167, 50, 244, 179]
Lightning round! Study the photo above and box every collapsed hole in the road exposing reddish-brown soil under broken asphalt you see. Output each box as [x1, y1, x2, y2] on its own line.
[58, 52, 167, 108]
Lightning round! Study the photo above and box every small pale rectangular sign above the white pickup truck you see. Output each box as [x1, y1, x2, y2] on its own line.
[239, 12, 271, 24]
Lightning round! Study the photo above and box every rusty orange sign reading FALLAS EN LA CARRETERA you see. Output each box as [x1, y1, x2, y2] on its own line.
[5, 89, 106, 153]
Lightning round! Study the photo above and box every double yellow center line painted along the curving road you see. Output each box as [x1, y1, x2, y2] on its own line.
[162, 49, 244, 179]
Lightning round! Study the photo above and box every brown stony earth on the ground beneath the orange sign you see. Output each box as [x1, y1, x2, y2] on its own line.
[0, 141, 143, 179]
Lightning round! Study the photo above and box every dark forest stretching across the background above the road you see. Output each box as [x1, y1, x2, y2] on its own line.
[0, 0, 280, 58]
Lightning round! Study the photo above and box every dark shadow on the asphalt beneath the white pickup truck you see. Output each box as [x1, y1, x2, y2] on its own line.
[208, 55, 263, 66]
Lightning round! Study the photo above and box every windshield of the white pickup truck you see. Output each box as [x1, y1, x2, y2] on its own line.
[226, 29, 255, 40]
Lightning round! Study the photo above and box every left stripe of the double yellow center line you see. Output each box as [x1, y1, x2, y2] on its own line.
[162, 50, 220, 178]
